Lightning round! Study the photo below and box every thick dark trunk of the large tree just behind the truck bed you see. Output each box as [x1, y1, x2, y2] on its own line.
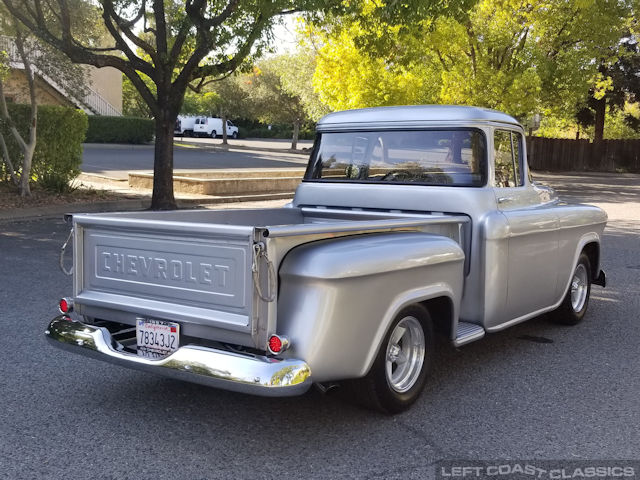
[151, 111, 178, 210]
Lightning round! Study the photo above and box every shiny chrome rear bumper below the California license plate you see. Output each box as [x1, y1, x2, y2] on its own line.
[45, 315, 312, 397]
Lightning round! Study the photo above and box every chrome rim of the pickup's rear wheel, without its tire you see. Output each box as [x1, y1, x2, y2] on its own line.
[385, 316, 425, 393]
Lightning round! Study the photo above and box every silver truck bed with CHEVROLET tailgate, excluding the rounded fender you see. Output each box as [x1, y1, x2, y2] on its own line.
[73, 207, 471, 349]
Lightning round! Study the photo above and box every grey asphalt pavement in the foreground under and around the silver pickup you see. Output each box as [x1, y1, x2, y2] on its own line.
[0, 175, 640, 479]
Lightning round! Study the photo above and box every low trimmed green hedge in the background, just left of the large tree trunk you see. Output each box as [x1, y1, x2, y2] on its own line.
[85, 115, 154, 143]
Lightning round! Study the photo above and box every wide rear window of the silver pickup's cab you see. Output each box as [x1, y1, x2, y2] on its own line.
[305, 129, 487, 187]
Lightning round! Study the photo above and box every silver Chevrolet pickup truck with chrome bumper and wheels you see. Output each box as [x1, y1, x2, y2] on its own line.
[46, 106, 607, 413]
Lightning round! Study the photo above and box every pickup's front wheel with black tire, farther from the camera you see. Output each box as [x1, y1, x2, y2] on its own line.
[551, 252, 592, 325]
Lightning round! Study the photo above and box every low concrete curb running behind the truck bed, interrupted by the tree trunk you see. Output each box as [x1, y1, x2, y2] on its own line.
[0, 192, 293, 224]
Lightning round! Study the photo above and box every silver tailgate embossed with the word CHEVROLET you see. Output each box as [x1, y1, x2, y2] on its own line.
[74, 215, 256, 335]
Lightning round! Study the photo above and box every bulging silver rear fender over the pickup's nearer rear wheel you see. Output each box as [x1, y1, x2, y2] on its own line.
[277, 232, 464, 382]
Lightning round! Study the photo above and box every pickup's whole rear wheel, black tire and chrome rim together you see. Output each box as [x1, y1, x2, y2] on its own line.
[354, 304, 433, 413]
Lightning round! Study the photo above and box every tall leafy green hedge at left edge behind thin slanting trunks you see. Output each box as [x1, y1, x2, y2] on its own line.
[0, 103, 87, 191]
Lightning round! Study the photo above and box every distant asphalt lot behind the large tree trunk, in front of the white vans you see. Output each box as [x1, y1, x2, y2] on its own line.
[80, 143, 308, 179]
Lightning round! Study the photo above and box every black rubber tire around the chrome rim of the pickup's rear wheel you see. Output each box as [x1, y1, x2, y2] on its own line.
[349, 304, 434, 414]
